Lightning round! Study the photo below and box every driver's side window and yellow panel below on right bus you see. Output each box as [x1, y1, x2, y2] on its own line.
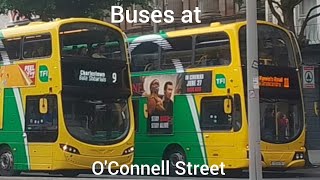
[200, 95, 241, 164]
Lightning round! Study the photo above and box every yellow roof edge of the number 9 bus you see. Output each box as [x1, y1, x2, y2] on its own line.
[0, 18, 122, 38]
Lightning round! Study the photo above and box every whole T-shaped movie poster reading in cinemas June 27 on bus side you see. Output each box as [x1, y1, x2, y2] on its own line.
[132, 71, 212, 134]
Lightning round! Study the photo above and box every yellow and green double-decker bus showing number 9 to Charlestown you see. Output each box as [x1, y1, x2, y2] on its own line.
[0, 18, 134, 176]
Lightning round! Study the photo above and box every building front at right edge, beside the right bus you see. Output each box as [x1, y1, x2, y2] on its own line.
[295, 0, 320, 164]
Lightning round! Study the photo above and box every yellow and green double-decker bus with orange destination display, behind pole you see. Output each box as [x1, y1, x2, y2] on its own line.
[128, 21, 306, 170]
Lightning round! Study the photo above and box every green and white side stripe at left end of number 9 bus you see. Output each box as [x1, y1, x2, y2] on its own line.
[0, 31, 30, 170]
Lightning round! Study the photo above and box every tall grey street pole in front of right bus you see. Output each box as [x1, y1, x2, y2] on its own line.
[246, 0, 262, 180]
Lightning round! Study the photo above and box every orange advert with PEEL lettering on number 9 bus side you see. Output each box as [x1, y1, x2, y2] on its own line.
[0, 63, 36, 87]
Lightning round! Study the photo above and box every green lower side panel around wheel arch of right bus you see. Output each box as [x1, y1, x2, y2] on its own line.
[134, 95, 206, 165]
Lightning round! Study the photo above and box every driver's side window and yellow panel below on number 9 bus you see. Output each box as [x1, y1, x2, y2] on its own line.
[25, 95, 58, 170]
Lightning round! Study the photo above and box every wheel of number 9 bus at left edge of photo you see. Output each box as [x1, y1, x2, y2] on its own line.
[0, 147, 15, 176]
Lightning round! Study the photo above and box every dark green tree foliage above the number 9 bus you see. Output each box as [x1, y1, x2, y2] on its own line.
[0, 0, 150, 21]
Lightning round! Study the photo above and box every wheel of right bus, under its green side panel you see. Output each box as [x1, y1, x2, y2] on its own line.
[164, 147, 186, 175]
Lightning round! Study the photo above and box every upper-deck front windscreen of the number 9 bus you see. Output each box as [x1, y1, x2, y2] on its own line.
[60, 23, 126, 61]
